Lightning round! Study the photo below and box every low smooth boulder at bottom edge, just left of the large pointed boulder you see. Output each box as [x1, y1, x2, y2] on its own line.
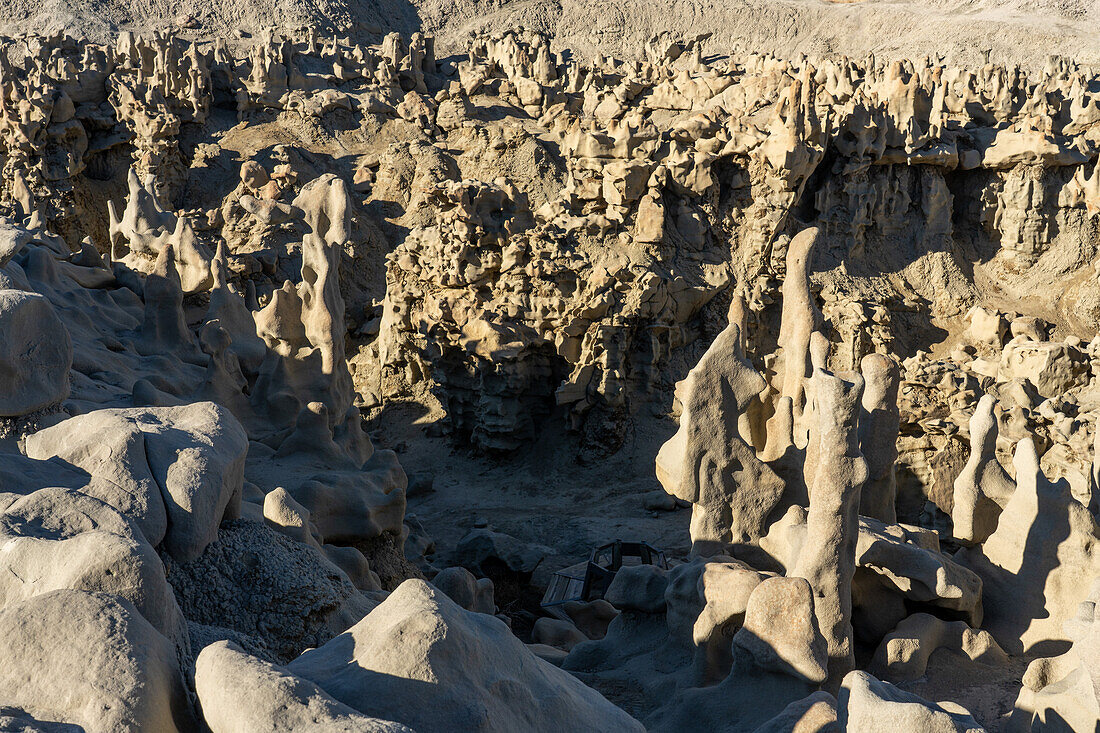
[195, 642, 413, 733]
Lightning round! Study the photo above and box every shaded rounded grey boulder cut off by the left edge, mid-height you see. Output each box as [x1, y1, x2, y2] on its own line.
[0, 291, 73, 417]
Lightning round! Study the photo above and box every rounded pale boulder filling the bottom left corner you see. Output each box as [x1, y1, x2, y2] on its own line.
[0, 590, 197, 733]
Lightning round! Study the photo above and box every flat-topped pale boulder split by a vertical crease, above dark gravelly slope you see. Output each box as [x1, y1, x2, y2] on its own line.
[24, 402, 249, 560]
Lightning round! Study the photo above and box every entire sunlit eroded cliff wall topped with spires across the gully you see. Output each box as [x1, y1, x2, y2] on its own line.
[0, 31, 1100, 521]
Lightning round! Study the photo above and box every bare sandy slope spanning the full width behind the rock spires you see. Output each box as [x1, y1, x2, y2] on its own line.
[8, 0, 1100, 68]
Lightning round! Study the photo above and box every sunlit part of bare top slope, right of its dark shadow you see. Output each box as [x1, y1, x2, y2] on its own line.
[418, 0, 1100, 68]
